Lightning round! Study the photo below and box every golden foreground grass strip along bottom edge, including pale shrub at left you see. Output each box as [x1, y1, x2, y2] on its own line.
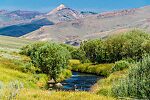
[0, 81, 115, 100]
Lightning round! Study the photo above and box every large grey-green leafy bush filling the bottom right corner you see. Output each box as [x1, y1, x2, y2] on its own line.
[112, 56, 150, 99]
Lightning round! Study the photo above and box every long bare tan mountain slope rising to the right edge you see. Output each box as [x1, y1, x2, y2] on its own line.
[24, 6, 150, 42]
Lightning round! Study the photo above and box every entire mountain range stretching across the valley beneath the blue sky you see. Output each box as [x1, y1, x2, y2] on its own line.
[0, 4, 150, 43]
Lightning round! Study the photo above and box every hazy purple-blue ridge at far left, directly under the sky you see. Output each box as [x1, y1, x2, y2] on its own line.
[0, 10, 43, 27]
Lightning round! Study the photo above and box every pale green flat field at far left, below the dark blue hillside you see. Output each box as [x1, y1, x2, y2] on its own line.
[0, 36, 33, 51]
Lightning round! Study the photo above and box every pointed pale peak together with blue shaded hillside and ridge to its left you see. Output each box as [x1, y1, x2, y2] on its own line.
[0, 4, 88, 37]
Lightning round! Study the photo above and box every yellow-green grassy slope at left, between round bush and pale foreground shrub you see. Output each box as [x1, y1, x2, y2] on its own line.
[0, 57, 47, 88]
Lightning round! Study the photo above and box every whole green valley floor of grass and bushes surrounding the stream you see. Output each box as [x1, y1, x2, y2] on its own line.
[0, 30, 150, 100]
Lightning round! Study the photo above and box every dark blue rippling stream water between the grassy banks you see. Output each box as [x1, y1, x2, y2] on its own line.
[62, 72, 103, 91]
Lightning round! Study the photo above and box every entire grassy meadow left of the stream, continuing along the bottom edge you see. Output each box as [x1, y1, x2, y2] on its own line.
[0, 36, 114, 100]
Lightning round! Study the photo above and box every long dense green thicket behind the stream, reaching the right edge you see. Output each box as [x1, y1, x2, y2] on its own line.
[79, 30, 150, 64]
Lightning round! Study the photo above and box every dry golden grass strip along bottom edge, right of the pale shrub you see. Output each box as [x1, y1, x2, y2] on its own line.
[16, 89, 115, 100]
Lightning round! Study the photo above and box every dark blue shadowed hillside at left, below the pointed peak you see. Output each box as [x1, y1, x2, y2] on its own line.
[0, 18, 54, 37]
